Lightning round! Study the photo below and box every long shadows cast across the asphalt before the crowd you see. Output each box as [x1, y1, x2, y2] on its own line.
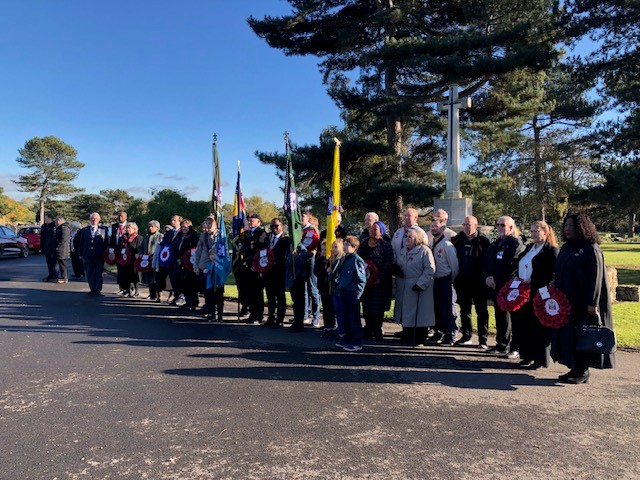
[0, 265, 555, 390]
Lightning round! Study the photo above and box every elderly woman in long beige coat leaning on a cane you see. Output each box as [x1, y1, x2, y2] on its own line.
[393, 230, 436, 345]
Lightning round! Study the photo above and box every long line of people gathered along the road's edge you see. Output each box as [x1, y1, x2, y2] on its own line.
[42, 208, 614, 384]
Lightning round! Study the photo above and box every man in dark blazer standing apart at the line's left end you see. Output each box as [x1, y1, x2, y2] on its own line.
[78, 212, 109, 296]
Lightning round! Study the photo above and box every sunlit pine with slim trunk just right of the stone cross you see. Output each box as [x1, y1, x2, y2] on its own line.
[471, 64, 602, 221]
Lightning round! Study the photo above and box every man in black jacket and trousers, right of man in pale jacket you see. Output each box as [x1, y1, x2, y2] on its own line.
[451, 216, 490, 350]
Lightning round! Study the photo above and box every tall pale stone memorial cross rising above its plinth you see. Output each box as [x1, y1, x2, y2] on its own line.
[438, 84, 471, 198]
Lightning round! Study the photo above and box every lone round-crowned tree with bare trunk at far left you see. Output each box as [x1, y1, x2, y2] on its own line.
[14, 136, 84, 224]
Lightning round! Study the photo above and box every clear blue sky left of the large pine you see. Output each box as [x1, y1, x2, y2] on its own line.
[0, 0, 340, 204]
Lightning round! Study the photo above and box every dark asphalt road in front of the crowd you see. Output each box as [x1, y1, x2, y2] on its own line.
[0, 256, 640, 480]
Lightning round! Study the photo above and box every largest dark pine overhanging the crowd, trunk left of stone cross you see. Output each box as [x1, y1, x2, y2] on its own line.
[249, 0, 559, 226]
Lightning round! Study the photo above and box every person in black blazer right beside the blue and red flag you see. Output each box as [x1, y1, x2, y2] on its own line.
[240, 213, 268, 323]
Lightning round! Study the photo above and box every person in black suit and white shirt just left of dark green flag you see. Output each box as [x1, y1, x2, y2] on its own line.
[263, 218, 291, 328]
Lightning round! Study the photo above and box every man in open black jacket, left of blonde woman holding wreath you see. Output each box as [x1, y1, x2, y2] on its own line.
[482, 217, 524, 358]
